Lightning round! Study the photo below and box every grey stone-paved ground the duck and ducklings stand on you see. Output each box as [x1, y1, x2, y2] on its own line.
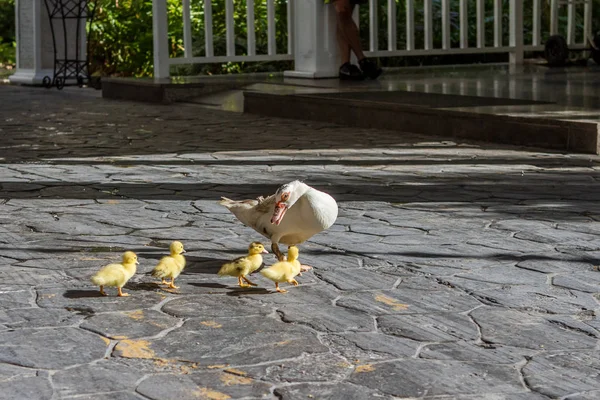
[0, 86, 600, 400]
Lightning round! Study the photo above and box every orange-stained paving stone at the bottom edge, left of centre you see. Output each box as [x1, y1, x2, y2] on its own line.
[137, 369, 271, 400]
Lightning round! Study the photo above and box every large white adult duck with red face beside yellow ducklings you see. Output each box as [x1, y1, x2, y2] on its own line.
[219, 181, 338, 271]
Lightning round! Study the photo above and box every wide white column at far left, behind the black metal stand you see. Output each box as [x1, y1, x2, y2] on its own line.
[9, 0, 58, 85]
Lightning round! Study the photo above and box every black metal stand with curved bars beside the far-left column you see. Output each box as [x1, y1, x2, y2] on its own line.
[42, 0, 96, 90]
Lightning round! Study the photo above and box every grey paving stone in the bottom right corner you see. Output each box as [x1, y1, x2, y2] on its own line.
[523, 351, 600, 398]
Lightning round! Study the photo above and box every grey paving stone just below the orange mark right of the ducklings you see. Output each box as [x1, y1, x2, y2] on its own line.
[377, 313, 479, 342]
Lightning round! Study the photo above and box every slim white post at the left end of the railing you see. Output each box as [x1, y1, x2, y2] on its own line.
[152, 0, 170, 78]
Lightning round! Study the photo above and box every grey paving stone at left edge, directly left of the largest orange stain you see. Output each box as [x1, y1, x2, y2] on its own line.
[0, 328, 108, 369]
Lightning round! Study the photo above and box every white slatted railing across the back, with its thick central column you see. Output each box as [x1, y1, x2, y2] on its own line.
[153, 0, 593, 77]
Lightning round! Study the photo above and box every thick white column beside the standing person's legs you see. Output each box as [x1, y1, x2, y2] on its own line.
[284, 0, 340, 79]
